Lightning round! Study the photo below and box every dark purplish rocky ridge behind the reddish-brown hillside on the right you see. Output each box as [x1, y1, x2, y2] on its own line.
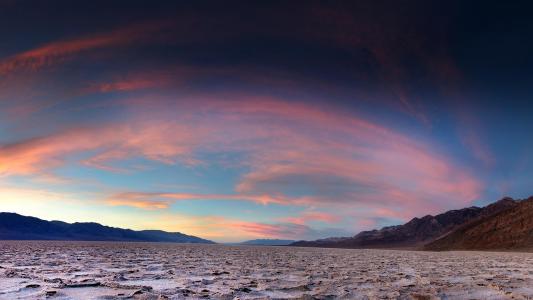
[292, 198, 516, 248]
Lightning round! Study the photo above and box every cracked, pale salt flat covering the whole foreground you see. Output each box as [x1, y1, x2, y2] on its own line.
[0, 241, 533, 299]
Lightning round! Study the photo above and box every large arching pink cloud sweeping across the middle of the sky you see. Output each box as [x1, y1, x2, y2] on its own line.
[0, 95, 482, 223]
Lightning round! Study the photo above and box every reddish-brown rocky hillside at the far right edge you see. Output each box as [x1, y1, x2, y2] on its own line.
[424, 197, 533, 250]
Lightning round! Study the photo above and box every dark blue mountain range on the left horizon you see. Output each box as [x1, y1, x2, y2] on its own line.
[0, 213, 214, 244]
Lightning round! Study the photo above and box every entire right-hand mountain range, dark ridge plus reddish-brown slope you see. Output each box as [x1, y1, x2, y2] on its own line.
[291, 197, 520, 250]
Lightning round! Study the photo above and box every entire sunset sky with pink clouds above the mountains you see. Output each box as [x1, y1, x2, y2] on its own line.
[0, 0, 533, 242]
